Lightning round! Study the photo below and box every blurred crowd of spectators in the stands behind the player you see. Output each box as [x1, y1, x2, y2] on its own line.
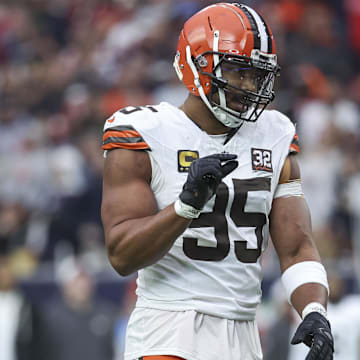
[0, 0, 360, 360]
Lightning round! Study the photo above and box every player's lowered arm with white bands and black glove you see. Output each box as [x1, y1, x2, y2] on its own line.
[270, 155, 334, 360]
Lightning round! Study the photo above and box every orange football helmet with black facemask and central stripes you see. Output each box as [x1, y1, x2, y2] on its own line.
[174, 3, 280, 127]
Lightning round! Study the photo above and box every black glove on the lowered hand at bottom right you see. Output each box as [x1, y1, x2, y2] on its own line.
[291, 312, 334, 360]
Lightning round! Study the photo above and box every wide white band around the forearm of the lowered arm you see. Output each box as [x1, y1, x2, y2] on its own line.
[281, 261, 329, 304]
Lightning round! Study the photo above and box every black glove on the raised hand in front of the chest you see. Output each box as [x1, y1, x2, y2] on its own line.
[179, 154, 238, 210]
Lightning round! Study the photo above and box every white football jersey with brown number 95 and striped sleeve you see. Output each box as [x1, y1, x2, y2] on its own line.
[103, 103, 296, 320]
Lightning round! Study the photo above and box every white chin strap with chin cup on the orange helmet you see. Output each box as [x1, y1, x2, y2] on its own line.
[186, 30, 243, 128]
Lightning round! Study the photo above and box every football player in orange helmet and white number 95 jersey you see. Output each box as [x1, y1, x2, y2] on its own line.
[102, 3, 333, 360]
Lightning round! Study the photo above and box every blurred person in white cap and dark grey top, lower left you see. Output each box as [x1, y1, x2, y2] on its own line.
[35, 258, 115, 360]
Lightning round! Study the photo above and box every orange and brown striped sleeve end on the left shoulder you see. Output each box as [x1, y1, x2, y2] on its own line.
[102, 126, 151, 150]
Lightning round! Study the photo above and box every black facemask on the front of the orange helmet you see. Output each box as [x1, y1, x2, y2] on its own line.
[194, 50, 279, 128]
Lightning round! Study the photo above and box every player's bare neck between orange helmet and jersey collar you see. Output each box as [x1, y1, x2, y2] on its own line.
[180, 94, 230, 135]
